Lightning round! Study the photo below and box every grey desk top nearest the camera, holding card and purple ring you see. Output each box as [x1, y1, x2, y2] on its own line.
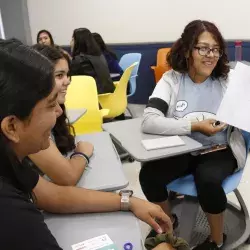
[45, 212, 143, 250]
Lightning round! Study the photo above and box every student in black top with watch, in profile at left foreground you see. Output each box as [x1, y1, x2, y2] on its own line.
[0, 39, 171, 250]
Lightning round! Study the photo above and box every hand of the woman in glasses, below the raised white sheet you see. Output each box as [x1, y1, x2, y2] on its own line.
[192, 119, 227, 136]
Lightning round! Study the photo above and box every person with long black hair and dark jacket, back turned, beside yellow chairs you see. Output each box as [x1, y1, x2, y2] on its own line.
[70, 28, 115, 94]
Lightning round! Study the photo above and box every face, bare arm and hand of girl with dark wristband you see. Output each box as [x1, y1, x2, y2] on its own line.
[29, 59, 94, 186]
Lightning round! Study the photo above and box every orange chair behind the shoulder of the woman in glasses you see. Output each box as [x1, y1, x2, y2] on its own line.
[151, 48, 171, 83]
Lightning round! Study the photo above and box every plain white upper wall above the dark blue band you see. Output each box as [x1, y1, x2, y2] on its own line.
[28, 0, 250, 45]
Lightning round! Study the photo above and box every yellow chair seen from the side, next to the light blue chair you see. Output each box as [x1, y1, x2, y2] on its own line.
[98, 62, 138, 118]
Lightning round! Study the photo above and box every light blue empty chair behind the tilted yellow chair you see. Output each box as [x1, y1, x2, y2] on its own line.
[119, 53, 142, 117]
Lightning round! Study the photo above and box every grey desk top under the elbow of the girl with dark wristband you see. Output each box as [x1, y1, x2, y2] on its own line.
[76, 132, 129, 191]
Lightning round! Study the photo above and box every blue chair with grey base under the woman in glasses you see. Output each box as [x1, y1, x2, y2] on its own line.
[167, 131, 250, 250]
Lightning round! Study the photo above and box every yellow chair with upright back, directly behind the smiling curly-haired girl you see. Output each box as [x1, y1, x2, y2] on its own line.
[65, 76, 109, 135]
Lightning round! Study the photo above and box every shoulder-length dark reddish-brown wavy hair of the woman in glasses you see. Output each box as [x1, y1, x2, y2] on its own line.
[167, 20, 230, 79]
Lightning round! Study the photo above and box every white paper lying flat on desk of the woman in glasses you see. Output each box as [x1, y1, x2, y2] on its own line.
[142, 135, 185, 150]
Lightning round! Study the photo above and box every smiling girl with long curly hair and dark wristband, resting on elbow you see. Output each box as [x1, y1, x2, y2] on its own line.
[26, 44, 93, 186]
